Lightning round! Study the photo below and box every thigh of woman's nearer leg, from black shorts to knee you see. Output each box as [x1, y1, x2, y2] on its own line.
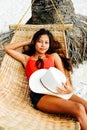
[37, 95, 80, 115]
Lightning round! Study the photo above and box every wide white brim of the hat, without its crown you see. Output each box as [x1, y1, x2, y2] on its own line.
[29, 69, 71, 99]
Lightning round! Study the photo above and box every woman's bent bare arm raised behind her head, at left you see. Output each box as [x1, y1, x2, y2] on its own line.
[4, 41, 30, 66]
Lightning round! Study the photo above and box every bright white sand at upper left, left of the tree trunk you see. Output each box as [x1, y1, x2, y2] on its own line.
[0, 0, 31, 33]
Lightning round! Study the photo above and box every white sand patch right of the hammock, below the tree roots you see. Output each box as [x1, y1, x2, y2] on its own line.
[72, 61, 87, 99]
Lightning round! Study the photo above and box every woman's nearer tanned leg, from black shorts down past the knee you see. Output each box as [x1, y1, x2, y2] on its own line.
[37, 95, 87, 130]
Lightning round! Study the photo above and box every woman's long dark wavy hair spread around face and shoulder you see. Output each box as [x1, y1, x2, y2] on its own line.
[23, 28, 72, 71]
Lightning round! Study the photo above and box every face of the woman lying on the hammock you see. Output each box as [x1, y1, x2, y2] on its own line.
[35, 34, 50, 54]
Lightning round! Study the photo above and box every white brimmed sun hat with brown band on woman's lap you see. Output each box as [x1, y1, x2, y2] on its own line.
[29, 67, 73, 99]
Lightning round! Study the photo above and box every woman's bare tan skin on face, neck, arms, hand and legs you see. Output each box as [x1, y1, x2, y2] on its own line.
[4, 34, 87, 130]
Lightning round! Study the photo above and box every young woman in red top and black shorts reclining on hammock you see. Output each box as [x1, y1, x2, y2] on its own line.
[4, 29, 87, 130]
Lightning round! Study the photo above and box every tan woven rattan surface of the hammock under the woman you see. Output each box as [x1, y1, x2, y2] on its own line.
[0, 25, 80, 130]
